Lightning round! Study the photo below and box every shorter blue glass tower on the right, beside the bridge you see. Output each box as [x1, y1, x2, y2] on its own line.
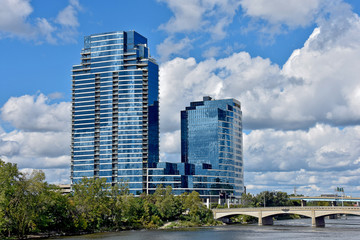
[181, 97, 244, 198]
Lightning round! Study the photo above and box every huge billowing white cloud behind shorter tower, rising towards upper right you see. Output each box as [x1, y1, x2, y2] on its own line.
[160, 2, 360, 132]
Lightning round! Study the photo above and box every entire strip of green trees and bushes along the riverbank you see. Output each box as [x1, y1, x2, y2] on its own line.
[0, 160, 217, 238]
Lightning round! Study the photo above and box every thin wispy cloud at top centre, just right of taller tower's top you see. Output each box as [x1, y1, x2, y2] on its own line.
[157, 0, 240, 61]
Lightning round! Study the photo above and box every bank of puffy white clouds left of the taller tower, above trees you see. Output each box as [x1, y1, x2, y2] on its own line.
[0, 94, 71, 183]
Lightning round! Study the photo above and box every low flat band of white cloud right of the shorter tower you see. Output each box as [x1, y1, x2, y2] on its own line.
[244, 124, 360, 171]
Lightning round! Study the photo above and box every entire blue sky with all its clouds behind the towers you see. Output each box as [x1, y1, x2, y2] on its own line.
[0, 0, 360, 196]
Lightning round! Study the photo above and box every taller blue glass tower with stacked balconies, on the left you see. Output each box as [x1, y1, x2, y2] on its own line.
[71, 31, 159, 194]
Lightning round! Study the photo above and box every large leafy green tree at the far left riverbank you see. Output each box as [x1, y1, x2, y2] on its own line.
[0, 160, 70, 238]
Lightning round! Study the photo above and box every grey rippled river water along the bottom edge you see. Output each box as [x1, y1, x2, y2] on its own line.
[54, 216, 360, 240]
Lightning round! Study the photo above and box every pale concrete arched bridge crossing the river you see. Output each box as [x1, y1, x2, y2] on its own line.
[212, 207, 360, 227]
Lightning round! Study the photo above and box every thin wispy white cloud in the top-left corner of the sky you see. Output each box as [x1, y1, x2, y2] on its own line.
[0, 0, 81, 44]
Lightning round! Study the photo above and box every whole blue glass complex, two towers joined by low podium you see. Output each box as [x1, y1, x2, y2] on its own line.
[71, 31, 244, 199]
